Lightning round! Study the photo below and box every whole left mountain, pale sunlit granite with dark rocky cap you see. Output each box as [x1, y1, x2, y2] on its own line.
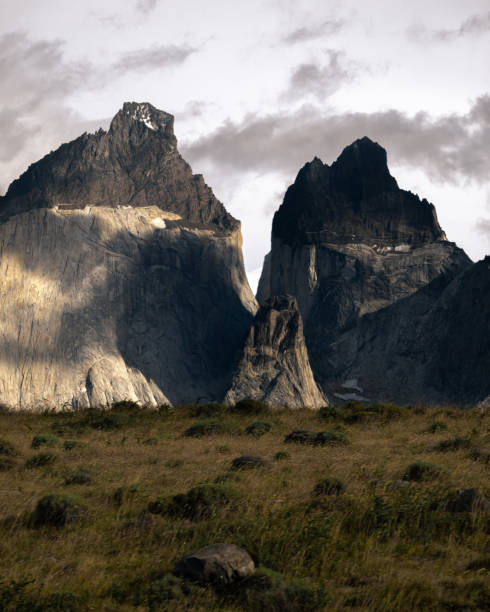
[0, 103, 257, 409]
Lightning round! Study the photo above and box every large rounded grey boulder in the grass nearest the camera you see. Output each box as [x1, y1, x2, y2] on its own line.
[174, 544, 255, 587]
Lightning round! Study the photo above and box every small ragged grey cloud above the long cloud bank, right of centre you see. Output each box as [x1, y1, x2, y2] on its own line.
[282, 49, 357, 101]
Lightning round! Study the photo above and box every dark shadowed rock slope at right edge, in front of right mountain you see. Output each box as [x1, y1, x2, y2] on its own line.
[330, 257, 490, 404]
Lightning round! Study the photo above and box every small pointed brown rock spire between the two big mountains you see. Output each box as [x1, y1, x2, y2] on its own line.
[225, 295, 327, 408]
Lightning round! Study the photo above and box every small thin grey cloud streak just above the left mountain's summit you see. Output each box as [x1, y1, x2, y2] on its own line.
[112, 45, 196, 76]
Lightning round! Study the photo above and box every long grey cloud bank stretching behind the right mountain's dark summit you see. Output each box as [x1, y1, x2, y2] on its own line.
[182, 95, 490, 184]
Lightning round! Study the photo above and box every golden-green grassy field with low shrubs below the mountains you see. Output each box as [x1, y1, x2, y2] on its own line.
[0, 404, 490, 612]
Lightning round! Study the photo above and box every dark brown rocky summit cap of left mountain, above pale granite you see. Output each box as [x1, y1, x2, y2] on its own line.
[0, 102, 239, 231]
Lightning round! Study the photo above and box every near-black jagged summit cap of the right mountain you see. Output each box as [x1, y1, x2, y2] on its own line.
[272, 136, 445, 247]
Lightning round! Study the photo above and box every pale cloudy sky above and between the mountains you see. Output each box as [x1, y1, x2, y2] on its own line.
[0, 0, 490, 288]
